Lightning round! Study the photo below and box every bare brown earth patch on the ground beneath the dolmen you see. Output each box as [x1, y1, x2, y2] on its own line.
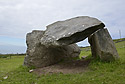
[33, 59, 90, 75]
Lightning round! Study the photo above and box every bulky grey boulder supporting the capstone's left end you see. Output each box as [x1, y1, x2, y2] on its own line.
[24, 30, 80, 67]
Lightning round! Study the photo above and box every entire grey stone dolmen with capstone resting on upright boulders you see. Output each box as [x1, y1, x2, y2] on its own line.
[24, 16, 119, 67]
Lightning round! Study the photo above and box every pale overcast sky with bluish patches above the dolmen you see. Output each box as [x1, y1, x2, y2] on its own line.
[0, 0, 125, 53]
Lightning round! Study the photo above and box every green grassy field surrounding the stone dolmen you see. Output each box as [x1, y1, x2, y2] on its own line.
[0, 38, 125, 84]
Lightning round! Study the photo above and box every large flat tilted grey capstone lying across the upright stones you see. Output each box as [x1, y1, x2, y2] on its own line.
[41, 16, 105, 46]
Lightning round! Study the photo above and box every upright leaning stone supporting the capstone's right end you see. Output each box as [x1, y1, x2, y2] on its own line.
[89, 29, 119, 61]
